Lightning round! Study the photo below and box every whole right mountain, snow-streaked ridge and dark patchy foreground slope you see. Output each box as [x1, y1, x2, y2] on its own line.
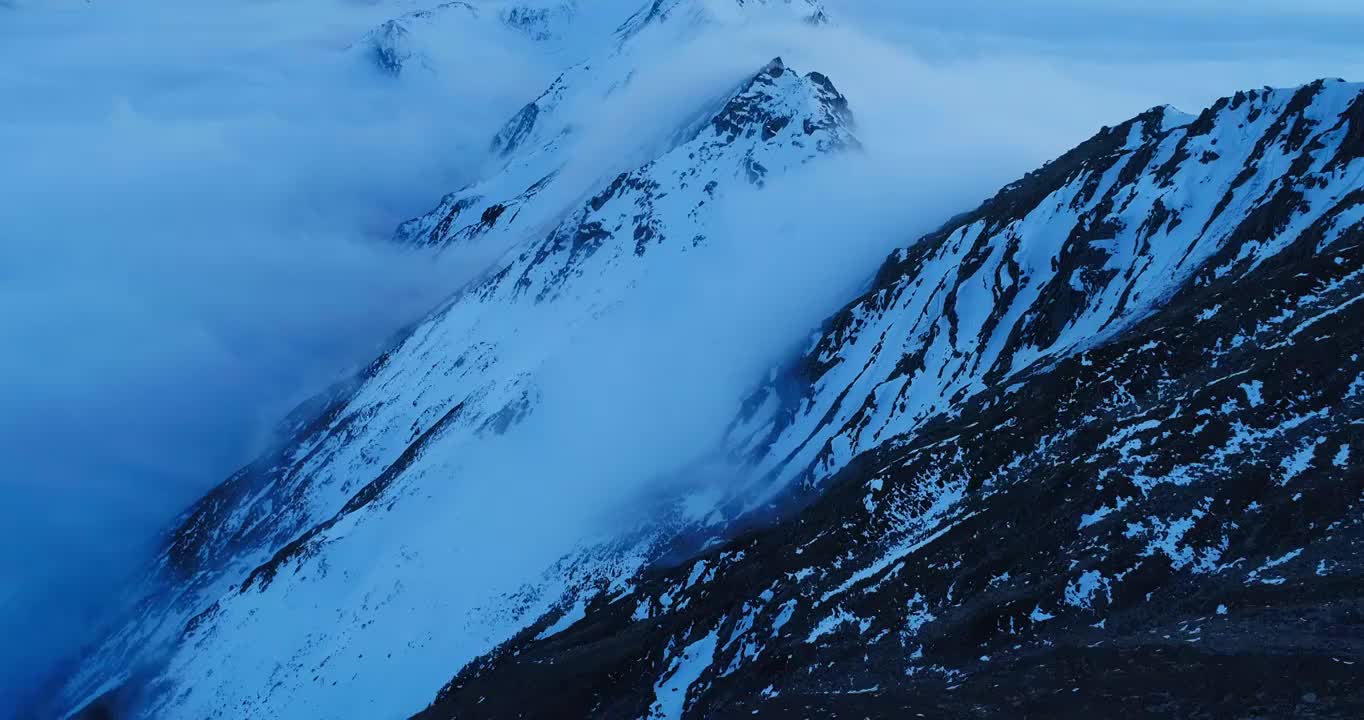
[414, 82, 1364, 717]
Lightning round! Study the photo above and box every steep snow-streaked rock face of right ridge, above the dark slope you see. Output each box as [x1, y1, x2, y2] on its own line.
[720, 83, 1359, 504]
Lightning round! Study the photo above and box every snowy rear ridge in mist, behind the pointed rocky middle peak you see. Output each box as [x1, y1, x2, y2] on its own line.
[394, 0, 824, 252]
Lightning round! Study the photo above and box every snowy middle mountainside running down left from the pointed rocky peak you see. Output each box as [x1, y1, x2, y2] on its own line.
[53, 9, 855, 717]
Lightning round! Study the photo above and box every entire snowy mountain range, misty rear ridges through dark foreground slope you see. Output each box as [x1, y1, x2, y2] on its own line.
[42, 0, 1364, 717]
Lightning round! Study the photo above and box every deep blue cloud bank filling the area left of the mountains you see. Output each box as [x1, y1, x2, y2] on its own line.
[0, 0, 552, 715]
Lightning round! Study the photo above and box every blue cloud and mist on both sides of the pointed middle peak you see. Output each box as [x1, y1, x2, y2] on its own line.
[0, 0, 1364, 709]
